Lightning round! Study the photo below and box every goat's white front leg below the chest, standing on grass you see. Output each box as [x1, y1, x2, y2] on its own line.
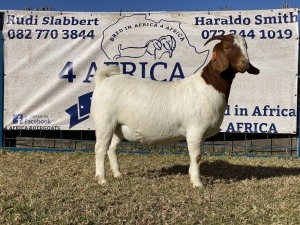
[187, 134, 203, 188]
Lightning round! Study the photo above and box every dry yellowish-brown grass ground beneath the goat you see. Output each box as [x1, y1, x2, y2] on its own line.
[0, 151, 300, 225]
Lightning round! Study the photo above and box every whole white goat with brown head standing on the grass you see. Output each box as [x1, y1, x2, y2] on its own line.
[91, 34, 259, 188]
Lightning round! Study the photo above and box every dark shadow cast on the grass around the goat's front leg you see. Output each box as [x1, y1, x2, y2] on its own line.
[158, 160, 300, 181]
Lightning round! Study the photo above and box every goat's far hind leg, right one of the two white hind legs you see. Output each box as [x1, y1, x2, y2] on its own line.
[107, 134, 122, 178]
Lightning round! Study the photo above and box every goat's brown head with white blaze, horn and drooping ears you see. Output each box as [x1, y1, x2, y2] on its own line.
[204, 34, 259, 74]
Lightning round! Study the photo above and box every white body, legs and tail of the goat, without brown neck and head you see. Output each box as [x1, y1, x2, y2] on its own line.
[91, 67, 227, 186]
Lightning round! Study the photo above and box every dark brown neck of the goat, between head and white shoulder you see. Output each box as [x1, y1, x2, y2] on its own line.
[201, 61, 236, 101]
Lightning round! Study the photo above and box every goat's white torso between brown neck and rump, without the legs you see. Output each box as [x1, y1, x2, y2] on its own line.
[91, 71, 226, 144]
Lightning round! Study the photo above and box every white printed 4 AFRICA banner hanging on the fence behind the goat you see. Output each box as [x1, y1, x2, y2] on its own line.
[3, 9, 299, 133]
